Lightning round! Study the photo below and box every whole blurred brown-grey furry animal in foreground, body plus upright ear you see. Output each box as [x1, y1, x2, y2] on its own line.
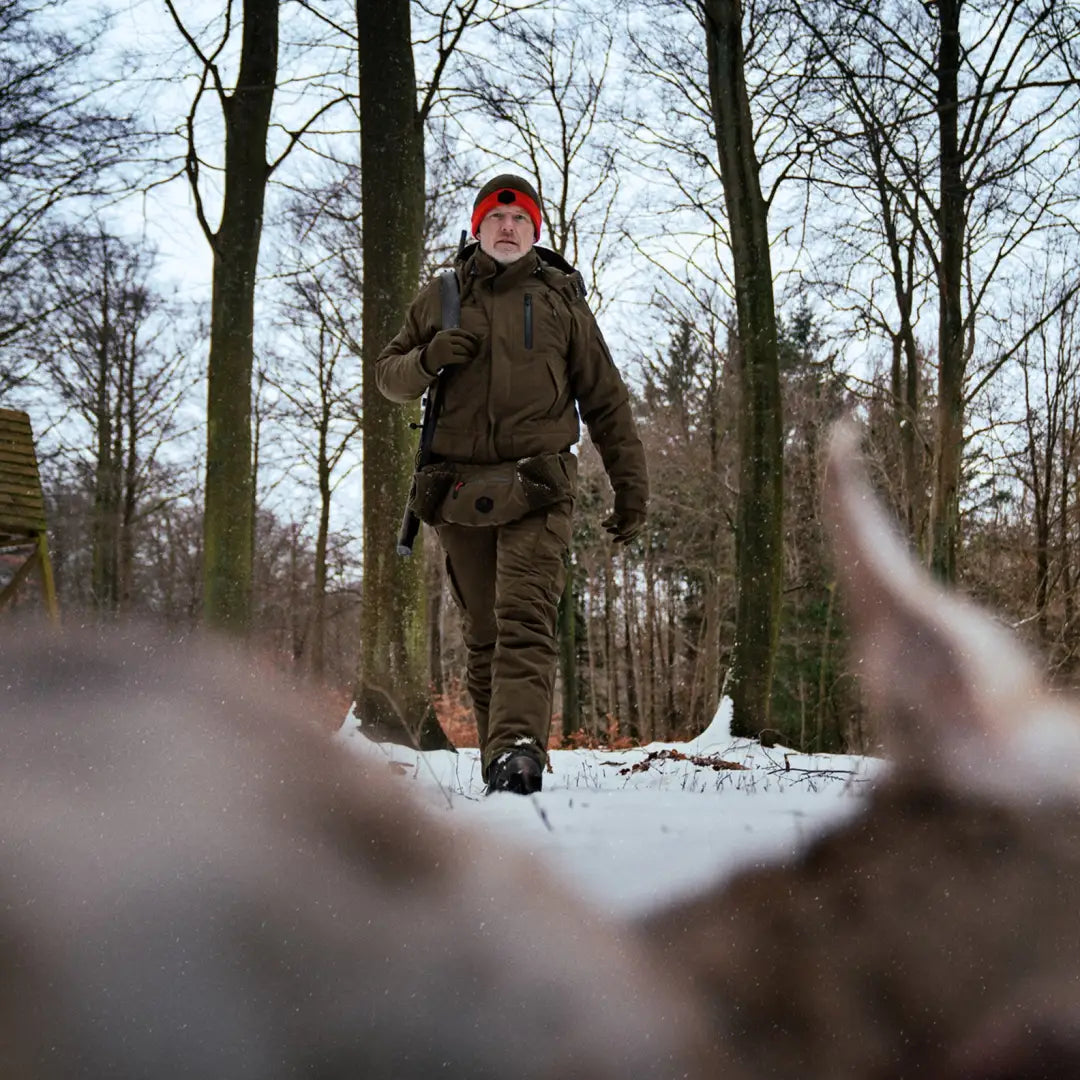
[8, 423, 1080, 1080]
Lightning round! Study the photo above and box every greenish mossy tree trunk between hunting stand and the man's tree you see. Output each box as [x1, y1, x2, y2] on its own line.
[203, 0, 279, 636]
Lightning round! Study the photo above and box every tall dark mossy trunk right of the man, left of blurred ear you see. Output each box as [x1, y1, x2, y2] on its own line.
[704, 0, 783, 735]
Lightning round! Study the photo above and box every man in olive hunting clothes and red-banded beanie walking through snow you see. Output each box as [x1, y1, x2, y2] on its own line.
[376, 174, 648, 795]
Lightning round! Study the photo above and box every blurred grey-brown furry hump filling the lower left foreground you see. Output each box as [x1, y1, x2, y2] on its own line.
[0, 631, 702, 1080]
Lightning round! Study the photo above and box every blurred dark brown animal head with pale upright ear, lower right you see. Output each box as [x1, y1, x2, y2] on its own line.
[649, 429, 1080, 1080]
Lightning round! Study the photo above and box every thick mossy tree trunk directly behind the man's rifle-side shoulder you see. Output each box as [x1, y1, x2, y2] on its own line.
[354, 0, 446, 746]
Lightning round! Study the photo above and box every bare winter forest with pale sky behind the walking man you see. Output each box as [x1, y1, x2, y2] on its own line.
[0, 0, 1080, 752]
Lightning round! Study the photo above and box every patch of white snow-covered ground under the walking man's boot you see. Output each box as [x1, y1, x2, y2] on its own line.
[338, 702, 883, 915]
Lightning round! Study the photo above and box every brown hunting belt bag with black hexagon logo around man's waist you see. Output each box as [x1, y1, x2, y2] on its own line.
[411, 453, 578, 525]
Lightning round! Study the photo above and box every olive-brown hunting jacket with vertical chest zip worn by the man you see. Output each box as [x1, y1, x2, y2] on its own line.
[376, 245, 649, 510]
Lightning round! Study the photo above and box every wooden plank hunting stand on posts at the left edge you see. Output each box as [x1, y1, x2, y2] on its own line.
[0, 408, 59, 622]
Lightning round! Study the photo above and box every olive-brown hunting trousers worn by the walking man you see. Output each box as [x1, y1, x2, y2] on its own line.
[438, 500, 572, 779]
